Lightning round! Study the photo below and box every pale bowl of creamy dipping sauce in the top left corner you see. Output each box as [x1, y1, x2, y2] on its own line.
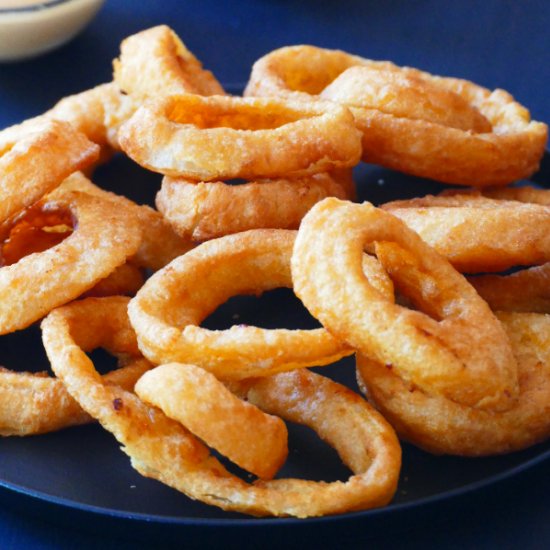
[0, 0, 105, 61]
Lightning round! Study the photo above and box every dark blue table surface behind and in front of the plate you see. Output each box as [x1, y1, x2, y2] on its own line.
[0, 0, 550, 549]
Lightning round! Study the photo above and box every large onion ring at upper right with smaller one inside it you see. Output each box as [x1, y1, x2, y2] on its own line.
[249, 46, 548, 187]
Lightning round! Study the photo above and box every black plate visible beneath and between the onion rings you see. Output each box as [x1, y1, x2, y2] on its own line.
[0, 149, 550, 536]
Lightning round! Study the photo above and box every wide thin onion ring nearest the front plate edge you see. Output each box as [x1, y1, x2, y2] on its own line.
[42, 302, 401, 517]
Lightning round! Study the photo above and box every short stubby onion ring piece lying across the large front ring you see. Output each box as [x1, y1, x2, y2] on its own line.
[135, 363, 288, 479]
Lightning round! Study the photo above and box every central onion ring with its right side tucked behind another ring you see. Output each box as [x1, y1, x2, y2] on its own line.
[128, 229, 352, 380]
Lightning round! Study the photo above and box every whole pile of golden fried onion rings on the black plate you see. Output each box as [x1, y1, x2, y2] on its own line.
[0, 25, 550, 517]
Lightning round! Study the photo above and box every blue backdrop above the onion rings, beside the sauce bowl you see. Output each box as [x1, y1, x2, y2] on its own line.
[0, 0, 550, 125]
